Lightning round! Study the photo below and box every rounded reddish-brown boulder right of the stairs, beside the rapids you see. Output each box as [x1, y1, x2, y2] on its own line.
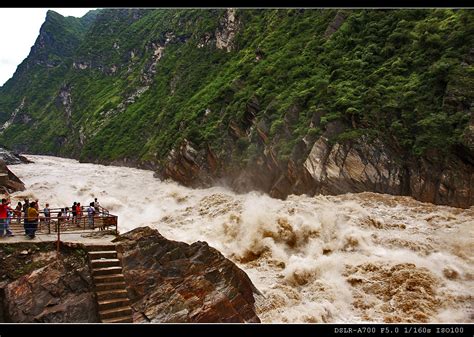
[117, 227, 260, 323]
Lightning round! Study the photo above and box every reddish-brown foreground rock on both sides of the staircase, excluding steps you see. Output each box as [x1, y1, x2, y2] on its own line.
[0, 227, 260, 323]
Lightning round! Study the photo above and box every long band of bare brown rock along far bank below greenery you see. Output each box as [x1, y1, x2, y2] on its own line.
[159, 121, 474, 208]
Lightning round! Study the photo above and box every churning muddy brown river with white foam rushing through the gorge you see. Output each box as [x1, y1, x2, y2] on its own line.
[9, 155, 474, 323]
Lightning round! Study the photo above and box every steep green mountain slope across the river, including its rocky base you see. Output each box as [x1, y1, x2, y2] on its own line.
[0, 9, 474, 207]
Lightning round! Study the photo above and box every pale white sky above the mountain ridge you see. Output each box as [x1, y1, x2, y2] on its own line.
[0, 8, 95, 86]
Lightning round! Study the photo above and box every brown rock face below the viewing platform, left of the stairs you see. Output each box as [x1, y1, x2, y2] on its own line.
[0, 243, 99, 323]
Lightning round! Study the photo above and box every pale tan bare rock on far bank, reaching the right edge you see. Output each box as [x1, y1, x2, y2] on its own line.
[304, 133, 474, 208]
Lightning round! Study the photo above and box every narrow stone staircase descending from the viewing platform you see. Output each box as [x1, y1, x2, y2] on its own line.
[86, 245, 133, 323]
